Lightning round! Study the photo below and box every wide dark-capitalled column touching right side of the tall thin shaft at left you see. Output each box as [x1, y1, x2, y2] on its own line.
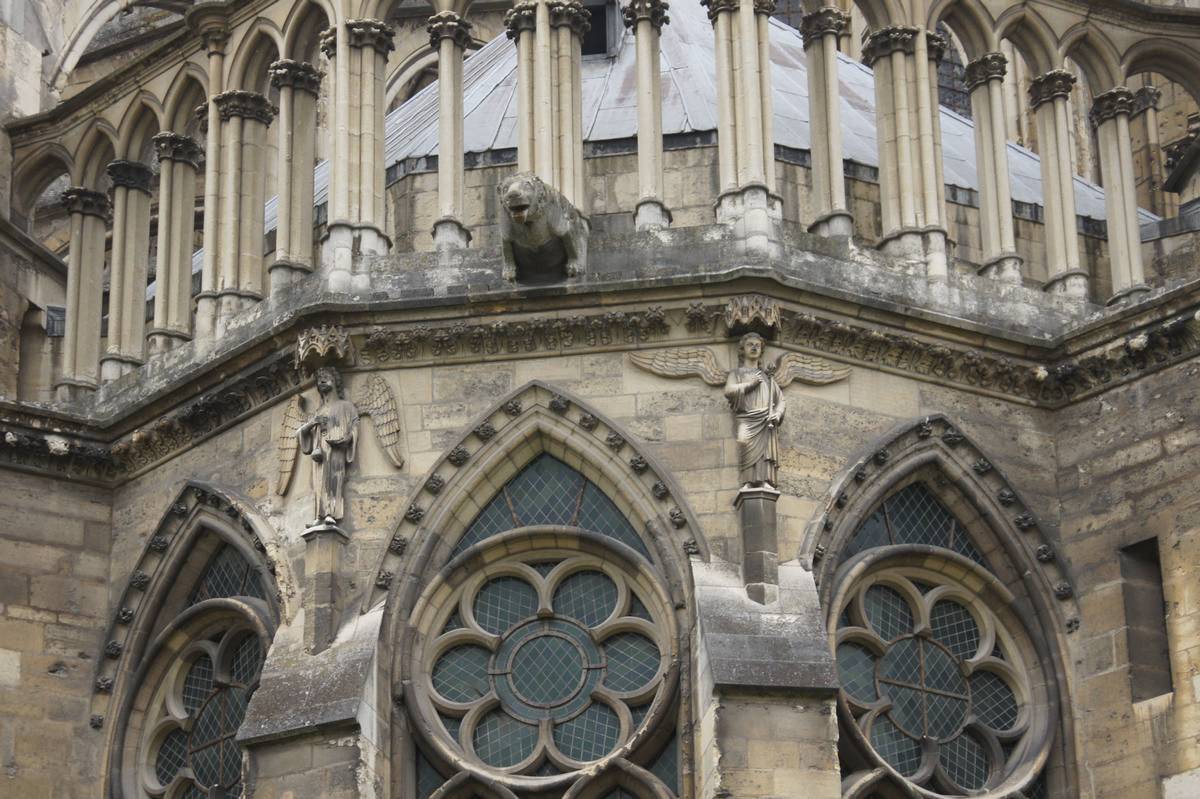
[216, 89, 277, 335]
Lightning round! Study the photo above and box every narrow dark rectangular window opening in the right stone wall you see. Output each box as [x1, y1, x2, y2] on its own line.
[1120, 539, 1174, 702]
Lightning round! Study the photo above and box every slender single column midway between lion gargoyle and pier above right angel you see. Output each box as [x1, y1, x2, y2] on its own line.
[622, 0, 671, 230]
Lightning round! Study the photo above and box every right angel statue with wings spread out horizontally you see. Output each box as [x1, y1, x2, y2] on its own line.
[629, 332, 850, 487]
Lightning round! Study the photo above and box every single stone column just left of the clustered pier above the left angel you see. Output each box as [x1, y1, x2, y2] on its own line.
[268, 59, 323, 296]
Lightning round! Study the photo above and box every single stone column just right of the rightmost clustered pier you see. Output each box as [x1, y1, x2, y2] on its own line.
[966, 53, 1022, 283]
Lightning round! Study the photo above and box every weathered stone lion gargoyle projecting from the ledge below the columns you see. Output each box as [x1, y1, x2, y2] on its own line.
[496, 172, 589, 283]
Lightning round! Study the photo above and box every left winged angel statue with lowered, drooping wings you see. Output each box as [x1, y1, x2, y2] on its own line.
[275, 366, 404, 527]
